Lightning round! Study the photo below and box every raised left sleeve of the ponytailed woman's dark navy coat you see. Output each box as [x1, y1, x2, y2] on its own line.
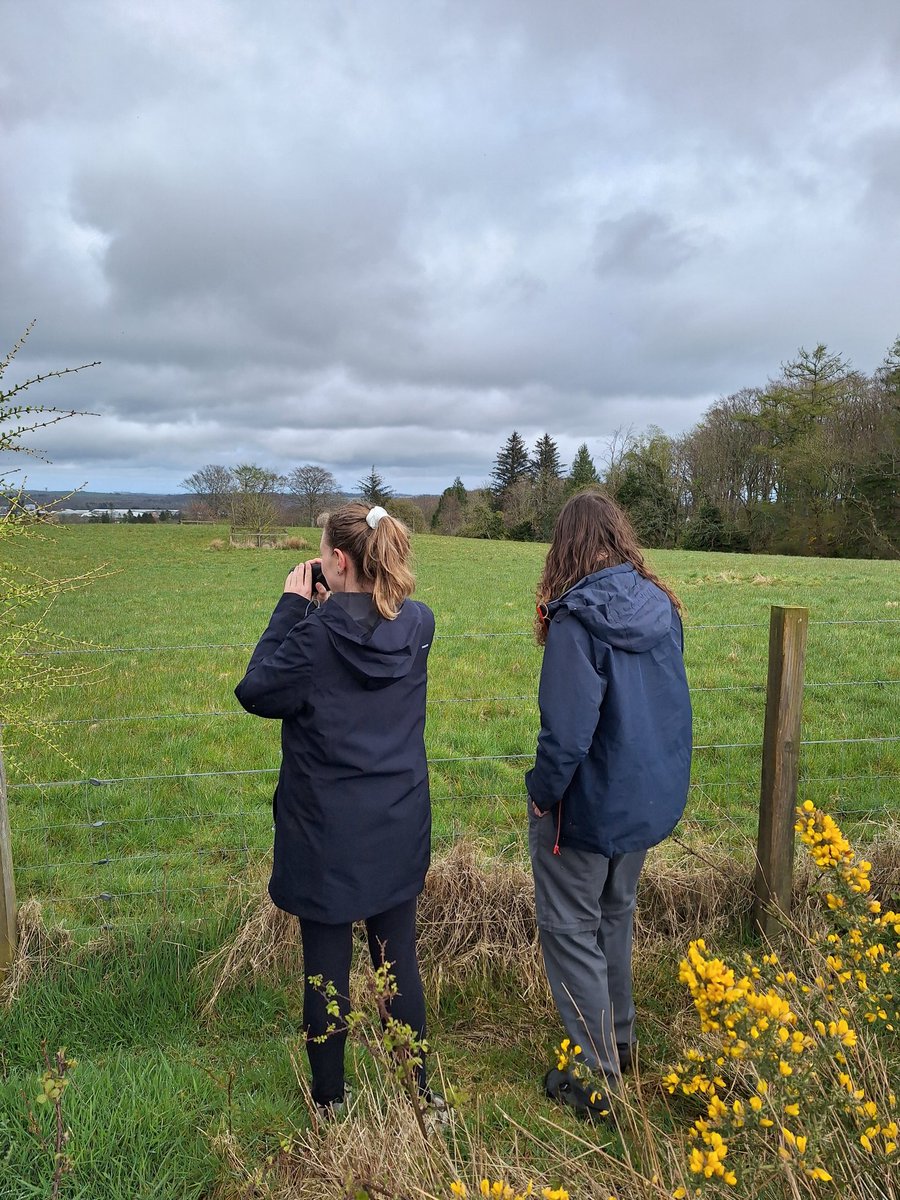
[234, 592, 314, 719]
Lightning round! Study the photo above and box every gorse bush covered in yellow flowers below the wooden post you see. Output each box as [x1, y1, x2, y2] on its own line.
[665, 802, 900, 1196]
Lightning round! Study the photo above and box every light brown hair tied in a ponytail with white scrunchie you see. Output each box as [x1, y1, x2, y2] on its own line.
[325, 500, 415, 620]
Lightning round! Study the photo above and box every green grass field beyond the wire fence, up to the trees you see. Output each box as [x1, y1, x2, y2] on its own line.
[7, 526, 900, 928]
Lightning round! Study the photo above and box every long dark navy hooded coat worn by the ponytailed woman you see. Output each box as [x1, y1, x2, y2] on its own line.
[235, 593, 434, 924]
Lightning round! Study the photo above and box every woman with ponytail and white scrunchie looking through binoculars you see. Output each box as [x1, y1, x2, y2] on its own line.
[235, 503, 444, 1115]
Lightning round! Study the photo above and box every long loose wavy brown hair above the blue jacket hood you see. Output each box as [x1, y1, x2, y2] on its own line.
[534, 490, 682, 646]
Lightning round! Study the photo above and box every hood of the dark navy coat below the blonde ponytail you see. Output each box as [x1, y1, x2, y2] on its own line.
[322, 594, 431, 688]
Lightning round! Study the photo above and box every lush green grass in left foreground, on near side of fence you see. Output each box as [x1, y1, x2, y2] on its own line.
[0, 924, 285, 1200]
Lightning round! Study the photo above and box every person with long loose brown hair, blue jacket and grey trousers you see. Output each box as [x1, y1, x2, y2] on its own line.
[526, 491, 691, 1116]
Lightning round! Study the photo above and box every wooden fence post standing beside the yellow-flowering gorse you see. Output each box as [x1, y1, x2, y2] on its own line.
[754, 605, 809, 937]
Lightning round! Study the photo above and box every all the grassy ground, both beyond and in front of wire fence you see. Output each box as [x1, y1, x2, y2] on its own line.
[0, 526, 900, 1200]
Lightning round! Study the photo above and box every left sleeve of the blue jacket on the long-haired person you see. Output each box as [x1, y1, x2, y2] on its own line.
[526, 616, 606, 811]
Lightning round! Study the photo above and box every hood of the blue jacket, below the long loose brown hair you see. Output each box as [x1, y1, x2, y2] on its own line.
[547, 563, 673, 654]
